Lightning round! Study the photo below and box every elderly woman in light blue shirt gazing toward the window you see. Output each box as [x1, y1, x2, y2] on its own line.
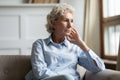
[25, 3, 105, 80]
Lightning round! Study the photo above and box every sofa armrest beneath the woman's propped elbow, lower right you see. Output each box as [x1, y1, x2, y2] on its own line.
[85, 69, 120, 80]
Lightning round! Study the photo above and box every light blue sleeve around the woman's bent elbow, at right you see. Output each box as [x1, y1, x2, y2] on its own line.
[78, 50, 105, 73]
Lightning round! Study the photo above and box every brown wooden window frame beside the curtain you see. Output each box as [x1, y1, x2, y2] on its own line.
[99, 0, 120, 60]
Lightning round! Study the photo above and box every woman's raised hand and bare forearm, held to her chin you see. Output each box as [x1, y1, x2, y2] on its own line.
[66, 27, 89, 51]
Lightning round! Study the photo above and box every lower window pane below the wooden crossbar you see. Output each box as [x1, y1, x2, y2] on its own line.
[104, 25, 120, 56]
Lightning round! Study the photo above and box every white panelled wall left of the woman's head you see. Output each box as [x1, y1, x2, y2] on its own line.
[0, 5, 54, 55]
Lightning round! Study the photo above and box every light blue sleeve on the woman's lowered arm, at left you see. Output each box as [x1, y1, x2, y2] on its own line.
[31, 42, 57, 79]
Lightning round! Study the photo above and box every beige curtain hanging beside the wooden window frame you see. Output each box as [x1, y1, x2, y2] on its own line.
[84, 0, 100, 55]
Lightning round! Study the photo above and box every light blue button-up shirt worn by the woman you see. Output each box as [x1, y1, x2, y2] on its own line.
[26, 36, 105, 80]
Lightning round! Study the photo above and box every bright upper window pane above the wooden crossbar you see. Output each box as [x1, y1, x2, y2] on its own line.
[103, 0, 120, 17]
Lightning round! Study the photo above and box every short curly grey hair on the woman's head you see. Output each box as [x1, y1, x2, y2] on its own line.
[46, 3, 74, 33]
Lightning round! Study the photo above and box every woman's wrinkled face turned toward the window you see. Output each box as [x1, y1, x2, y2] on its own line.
[52, 12, 73, 36]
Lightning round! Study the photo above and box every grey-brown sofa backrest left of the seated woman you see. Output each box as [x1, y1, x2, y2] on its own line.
[0, 55, 31, 80]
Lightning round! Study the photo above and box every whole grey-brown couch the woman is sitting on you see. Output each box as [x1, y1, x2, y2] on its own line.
[0, 55, 120, 80]
